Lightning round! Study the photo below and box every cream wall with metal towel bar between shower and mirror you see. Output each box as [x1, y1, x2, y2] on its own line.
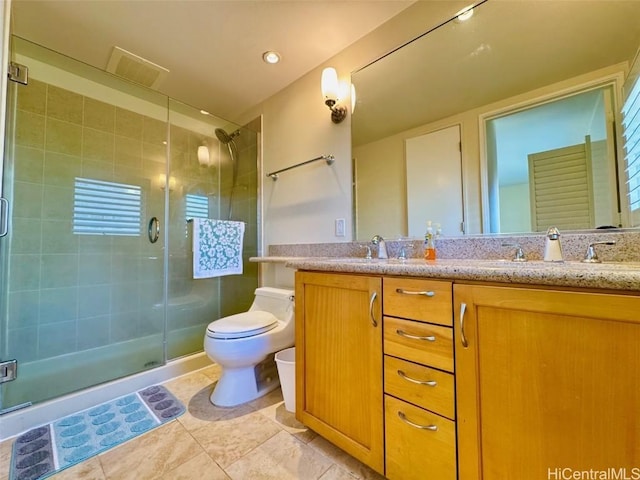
[262, 72, 351, 245]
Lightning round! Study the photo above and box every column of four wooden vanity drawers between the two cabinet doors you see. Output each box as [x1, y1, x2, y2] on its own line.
[383, 277, 456, 480]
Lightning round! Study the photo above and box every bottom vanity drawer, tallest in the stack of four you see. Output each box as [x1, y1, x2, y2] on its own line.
[384, 395, 456, 480]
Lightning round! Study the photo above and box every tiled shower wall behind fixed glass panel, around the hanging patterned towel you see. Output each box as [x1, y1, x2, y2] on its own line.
[168, 117, 258, 358]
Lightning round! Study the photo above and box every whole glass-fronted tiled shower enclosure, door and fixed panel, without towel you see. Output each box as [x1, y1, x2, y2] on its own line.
[0, 37, 258, 413]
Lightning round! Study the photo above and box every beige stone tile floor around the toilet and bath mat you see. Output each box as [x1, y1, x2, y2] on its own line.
[0, 365, 383, 480]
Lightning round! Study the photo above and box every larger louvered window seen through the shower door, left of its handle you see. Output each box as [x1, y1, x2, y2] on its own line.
[73, 177, 142, 236]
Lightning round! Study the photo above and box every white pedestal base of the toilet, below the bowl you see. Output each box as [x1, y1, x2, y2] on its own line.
[210, 354, 280, 407]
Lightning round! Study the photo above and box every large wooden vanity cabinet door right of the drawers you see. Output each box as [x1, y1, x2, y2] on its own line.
[454, 284, 640, 480]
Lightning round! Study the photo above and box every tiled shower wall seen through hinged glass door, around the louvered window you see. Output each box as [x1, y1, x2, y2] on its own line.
[8, 79, 166, 361]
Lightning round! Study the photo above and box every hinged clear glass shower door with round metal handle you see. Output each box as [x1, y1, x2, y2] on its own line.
[0, 37, 168, 411]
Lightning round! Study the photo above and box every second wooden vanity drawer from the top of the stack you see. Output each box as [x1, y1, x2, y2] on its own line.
[383, 317, 453, 372]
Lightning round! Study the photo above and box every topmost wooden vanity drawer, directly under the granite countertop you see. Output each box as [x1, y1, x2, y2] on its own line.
[382, 278, 453, 326]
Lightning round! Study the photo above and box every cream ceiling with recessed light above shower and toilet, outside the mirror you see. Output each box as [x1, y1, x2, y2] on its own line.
[12, 0, 414, 120]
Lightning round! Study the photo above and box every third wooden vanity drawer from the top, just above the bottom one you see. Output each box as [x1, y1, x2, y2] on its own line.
[384, 355, 456, 419]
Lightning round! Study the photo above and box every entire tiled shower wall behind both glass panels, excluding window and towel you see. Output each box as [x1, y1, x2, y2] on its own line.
[6, 79, 257, 362]
